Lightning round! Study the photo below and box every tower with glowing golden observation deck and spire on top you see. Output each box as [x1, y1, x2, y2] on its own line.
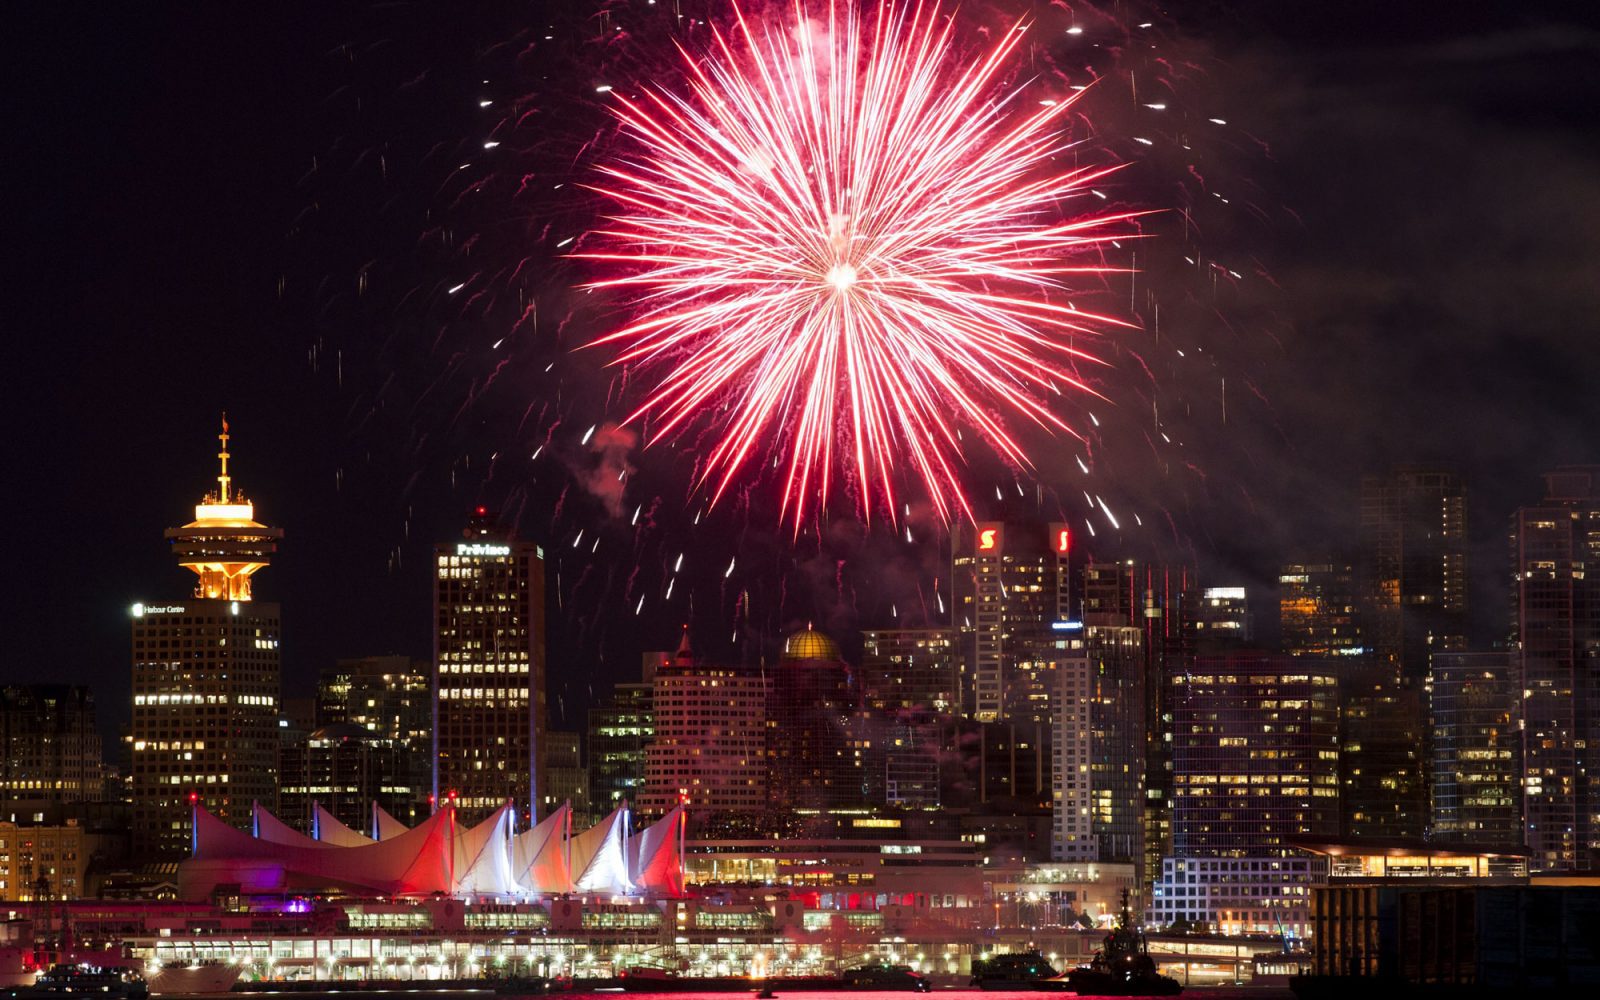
[130, 419, 283, 858]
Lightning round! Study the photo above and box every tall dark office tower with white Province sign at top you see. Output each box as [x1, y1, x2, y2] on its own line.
[434, 507, 547, 822]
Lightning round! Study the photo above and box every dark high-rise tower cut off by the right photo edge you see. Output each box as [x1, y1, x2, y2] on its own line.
[1512, 466, 1600, 872]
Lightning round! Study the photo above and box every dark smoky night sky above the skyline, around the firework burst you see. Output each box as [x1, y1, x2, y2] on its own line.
[0, 0, 1600, 730]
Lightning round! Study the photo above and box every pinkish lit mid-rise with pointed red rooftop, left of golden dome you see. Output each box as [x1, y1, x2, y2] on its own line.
[638, 634, 768, 816]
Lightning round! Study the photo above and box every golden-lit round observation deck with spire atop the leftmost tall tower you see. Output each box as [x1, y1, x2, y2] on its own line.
[166, 416, 283, 600]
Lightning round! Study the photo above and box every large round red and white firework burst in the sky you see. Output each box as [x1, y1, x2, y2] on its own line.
[574, 0, 1141, 531]
